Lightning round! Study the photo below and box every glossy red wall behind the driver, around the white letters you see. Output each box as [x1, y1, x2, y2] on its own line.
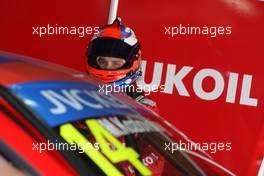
[0, 0, 264, 176]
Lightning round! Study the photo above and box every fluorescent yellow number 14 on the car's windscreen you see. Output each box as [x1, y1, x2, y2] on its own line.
[60, 119, 151, 176]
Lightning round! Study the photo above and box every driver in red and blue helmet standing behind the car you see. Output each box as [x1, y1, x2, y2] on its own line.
[86, 18, 158, 113]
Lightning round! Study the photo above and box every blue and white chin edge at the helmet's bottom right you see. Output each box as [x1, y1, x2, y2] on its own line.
[110, 68, 142, 88]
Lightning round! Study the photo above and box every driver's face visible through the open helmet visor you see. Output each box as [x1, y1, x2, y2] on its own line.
[96, 56, 126, 70]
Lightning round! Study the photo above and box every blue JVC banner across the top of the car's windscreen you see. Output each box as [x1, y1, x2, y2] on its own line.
[11, 81, 139, 127]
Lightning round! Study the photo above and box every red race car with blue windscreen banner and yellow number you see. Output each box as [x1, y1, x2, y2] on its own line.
[0, 52, 235, 176]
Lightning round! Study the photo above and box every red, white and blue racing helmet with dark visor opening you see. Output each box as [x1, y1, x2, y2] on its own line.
[86, 18, 141, 85]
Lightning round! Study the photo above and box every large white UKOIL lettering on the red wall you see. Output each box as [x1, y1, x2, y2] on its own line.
[138, 61, 258, 107]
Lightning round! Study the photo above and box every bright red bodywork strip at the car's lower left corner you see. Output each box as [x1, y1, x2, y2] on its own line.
[0, 99, 78, 176]
